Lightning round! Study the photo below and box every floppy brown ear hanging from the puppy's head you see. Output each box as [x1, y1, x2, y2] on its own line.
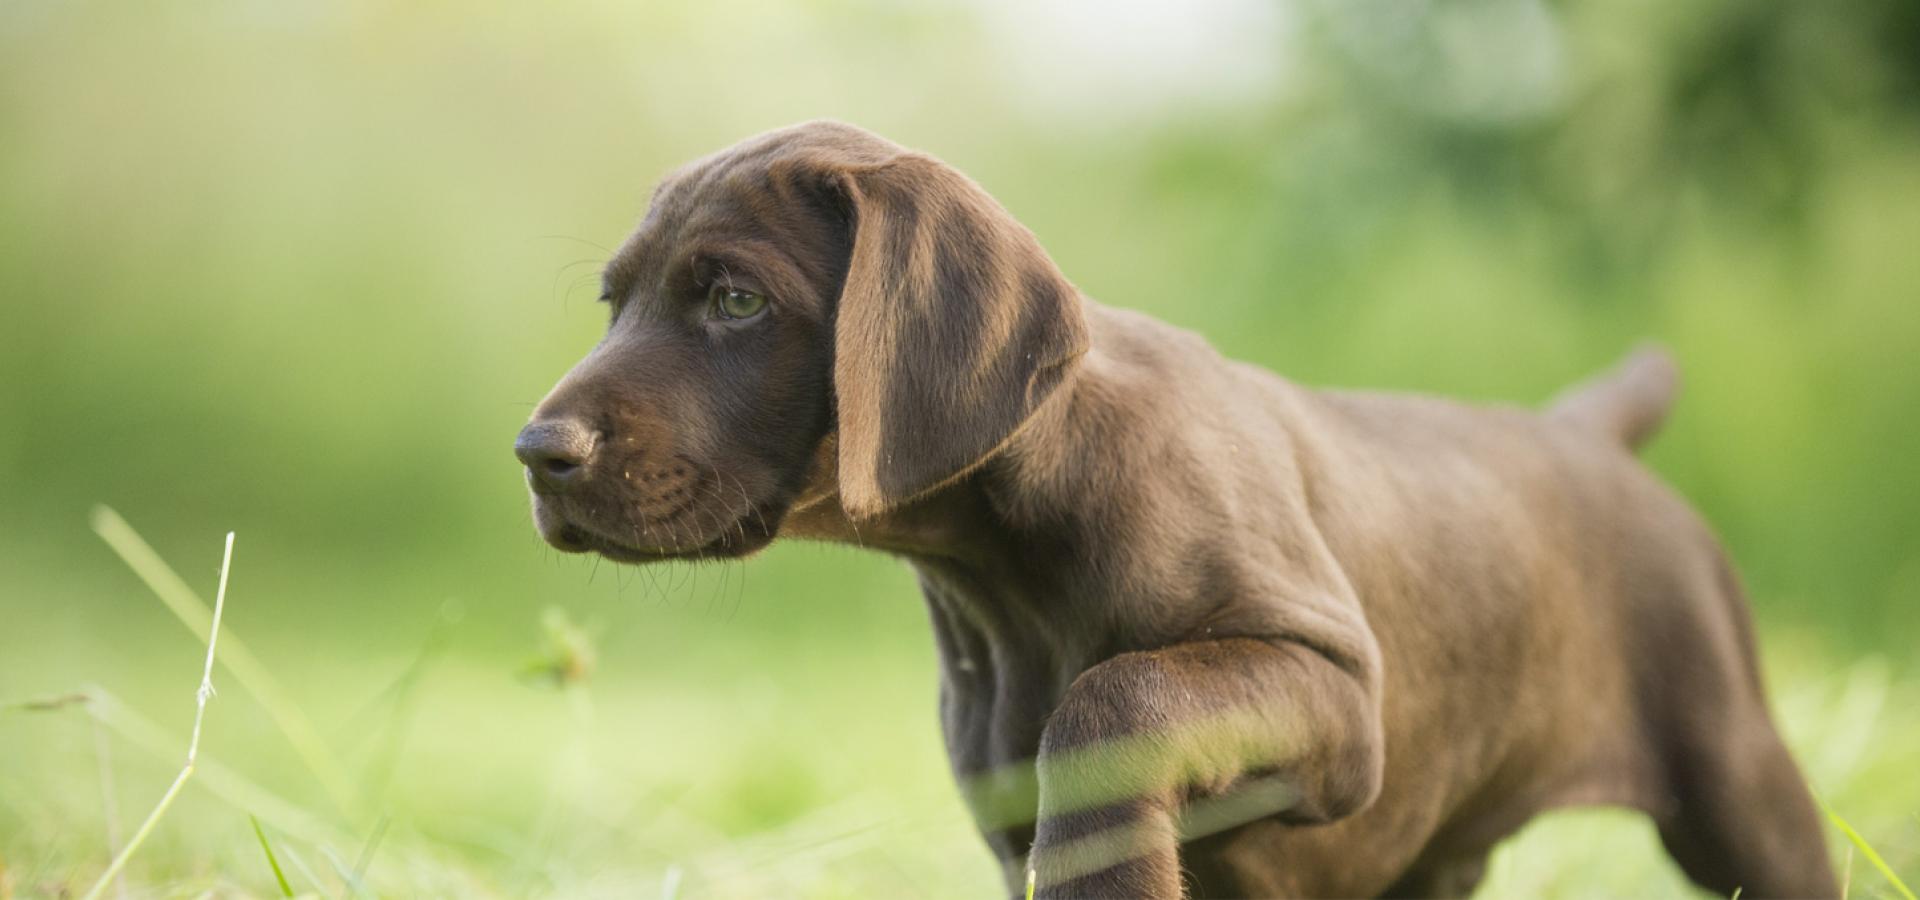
[833, 152, 1087, 518]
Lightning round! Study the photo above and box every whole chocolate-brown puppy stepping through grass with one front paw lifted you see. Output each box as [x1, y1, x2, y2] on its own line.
[516, 123, 1834, 896]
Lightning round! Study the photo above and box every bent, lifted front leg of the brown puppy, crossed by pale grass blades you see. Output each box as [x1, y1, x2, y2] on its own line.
[1029, 639, 1384, 898]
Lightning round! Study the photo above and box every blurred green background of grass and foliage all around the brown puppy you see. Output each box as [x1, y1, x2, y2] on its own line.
[0, 0, 1920, 896]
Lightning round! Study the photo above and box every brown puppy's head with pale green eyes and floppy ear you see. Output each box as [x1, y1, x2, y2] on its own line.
[515, 123, 1087, 562]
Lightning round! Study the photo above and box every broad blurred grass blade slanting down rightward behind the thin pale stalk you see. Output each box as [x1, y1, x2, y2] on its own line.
[92, 507, 359, 817]
